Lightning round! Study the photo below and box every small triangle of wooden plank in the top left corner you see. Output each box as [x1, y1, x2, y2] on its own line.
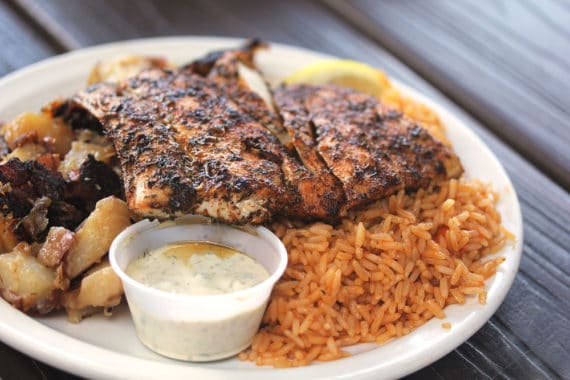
[0, 2, 59, 76]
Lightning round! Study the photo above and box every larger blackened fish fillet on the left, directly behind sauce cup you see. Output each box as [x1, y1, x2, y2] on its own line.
[74, 70, 291, 223]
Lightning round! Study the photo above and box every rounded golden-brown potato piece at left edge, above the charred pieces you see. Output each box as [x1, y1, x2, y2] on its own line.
[1, 112, 74, 154]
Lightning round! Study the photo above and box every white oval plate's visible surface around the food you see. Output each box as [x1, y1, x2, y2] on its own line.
[0, 37, 522, 380]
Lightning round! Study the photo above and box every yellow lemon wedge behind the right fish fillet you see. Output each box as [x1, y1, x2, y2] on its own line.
[285, 59, 390, 97]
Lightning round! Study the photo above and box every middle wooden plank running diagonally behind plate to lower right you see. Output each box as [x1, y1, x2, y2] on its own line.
[0, 0, 570, 379]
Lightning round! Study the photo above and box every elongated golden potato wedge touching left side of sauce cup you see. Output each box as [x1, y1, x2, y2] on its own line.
[64, 196, 131, 279]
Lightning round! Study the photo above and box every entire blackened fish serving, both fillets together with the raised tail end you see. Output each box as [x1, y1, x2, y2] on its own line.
[73, 42, 463, 224]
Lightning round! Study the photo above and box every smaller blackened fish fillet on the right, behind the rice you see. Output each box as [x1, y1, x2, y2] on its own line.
[275, 85, 463, 210]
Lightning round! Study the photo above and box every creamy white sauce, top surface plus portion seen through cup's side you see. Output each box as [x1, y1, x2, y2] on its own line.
[125, 241, 269, 361]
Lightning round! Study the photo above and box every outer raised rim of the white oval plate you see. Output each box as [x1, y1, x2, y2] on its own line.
[0, 36, 523, 379]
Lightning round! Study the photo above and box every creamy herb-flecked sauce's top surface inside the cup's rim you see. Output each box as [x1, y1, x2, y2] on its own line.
[126, 241, 269, 295]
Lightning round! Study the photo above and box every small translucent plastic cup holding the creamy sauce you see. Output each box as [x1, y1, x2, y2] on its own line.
[109, 216, 287, 361]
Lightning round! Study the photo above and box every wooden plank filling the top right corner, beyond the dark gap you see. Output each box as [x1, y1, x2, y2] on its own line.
[327, 0, 570, 190]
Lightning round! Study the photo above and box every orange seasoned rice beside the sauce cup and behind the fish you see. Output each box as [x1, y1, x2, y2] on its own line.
[239, 75, 508, 367]
